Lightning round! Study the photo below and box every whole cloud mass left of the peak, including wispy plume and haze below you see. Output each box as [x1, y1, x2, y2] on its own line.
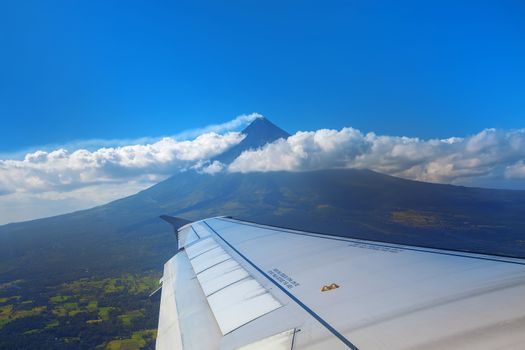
[0, 114, 255, 224]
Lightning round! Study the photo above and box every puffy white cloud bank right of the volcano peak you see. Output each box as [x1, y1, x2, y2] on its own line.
[228, 128, 525, 184]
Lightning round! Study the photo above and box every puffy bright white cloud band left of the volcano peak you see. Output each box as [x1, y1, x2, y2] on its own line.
[0, 132, 243, 197]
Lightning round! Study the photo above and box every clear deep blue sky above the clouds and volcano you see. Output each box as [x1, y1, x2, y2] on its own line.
[0, 0, 525, 152]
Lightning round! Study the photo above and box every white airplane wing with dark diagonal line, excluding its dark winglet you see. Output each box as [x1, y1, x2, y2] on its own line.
[156, 218, 525, 350]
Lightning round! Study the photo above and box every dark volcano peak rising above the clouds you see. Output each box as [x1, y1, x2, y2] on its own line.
[213, 117, 290, 164]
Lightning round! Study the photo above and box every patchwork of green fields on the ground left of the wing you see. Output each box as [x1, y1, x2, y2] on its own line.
[0, 272, 160, 349]
